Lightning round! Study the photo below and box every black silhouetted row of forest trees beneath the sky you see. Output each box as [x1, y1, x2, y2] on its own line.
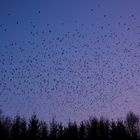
[0, 111, 140, 140]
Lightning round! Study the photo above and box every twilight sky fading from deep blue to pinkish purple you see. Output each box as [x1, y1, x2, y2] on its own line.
[0, 0, 140, 122]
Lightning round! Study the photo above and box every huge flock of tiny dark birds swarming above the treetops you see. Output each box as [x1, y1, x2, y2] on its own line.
[0, 6, 140, 121]
